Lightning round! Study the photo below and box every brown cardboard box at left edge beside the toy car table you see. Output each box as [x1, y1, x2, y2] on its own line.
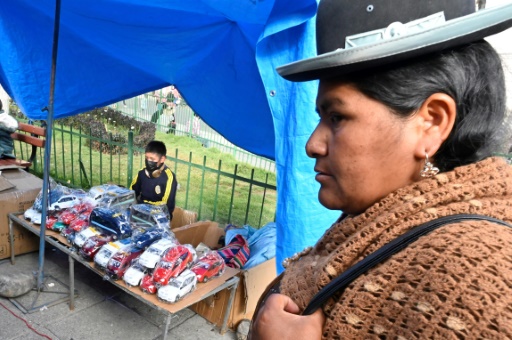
[0, 169, 43, 259]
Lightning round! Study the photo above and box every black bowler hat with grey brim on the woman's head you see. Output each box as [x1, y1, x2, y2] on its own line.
[277, 0, 512, 81]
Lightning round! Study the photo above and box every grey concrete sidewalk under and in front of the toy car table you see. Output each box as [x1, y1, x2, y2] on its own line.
[0, 247, 236, 340]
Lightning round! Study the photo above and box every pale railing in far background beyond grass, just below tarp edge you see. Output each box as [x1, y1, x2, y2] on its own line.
[110, 90, 275, 172]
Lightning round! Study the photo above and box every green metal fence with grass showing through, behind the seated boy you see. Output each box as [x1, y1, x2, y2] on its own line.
[15, 125, 276, 227]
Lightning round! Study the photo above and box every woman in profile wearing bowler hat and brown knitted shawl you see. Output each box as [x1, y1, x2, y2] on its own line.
[250, 0, 512, 340]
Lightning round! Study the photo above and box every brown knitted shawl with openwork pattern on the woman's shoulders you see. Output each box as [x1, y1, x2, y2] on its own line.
[281, 158, 512, 339]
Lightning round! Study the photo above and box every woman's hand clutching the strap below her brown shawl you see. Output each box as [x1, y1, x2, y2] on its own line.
[250, 294, 325, 340]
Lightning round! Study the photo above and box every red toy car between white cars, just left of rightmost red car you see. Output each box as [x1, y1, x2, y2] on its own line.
[153, 245, 194, 286]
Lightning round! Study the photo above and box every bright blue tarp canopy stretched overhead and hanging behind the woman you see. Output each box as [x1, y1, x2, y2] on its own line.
[0, 0, 339, 269]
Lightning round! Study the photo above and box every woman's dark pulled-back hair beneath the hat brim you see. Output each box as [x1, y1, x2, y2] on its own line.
[348, 40, 506, 171]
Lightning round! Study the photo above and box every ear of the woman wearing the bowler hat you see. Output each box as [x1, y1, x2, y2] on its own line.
[416, 93, 457, 159]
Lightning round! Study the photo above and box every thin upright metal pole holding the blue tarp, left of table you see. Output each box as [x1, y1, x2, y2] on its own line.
[37, 0, 61, 291]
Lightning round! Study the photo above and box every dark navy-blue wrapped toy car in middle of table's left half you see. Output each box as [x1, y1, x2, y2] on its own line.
[89, 207, 132, 239]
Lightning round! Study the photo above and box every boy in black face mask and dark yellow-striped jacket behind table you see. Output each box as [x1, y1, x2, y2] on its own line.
[130, 141, 178, 219]
